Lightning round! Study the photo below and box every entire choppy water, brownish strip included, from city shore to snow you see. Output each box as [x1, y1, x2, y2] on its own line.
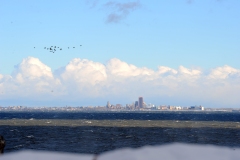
[0, 112, 240, 153]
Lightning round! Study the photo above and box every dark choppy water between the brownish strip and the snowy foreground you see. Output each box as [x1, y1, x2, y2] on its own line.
[1, 126, 240, 153]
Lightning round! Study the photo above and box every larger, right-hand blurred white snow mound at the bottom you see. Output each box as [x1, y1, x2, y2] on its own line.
[98, 143, 240, 160]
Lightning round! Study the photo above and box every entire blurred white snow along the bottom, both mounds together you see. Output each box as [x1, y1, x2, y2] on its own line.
[1, 143, 240, 160]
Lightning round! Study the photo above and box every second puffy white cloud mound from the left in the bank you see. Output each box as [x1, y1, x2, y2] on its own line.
[56, 58, 107, 99]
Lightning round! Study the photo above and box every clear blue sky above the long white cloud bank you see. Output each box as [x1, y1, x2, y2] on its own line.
[0, 0, 240, 106]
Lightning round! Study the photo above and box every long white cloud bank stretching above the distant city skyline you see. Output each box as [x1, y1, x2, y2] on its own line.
[0, 57, 240, 107]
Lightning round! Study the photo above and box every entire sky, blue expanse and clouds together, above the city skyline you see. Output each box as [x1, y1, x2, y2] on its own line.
[0, 0, 240, 108]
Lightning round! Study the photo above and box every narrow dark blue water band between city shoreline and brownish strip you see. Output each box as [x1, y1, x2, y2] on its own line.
[0, 112, 240, 122]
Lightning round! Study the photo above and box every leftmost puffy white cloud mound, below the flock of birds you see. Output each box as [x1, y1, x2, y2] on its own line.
[1, 57, 60, 99]
